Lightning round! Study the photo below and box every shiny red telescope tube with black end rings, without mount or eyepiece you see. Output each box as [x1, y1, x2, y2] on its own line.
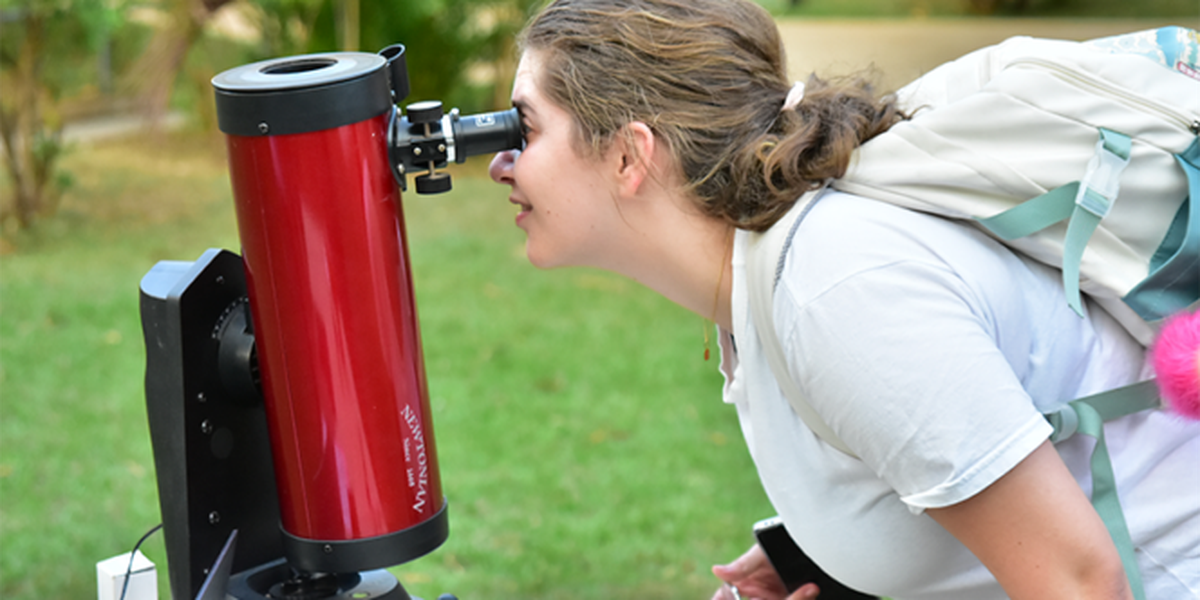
[212, 53, 449, 572]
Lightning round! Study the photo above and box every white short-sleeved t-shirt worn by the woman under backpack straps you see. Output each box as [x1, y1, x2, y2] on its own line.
[721, 193, 1200, 600]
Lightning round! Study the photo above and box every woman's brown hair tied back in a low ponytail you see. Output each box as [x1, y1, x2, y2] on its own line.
[521, 0, 905, 230]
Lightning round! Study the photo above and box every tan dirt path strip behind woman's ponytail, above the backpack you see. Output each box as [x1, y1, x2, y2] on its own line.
[779, 19, 1200, 89]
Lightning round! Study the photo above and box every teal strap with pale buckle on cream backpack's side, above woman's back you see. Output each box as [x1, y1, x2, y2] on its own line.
[978, 128, 1133, 316]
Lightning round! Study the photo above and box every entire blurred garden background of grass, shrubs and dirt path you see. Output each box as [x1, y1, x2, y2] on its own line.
[0, 0, 1200, 600]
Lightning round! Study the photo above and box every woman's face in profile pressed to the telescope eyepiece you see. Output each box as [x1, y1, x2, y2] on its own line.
[488, 52, 622, 269]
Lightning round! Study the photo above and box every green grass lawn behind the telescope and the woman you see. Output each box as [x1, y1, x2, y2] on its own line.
[0, 136, 770, 600]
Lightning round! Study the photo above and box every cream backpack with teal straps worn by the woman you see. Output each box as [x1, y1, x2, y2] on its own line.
[746, 28, 1200, 600]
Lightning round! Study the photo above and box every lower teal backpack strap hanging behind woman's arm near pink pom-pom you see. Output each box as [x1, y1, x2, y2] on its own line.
[1046, 379, 1162, 600]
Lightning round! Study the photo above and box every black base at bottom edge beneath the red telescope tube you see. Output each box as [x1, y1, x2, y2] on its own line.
[227, 559, 420, 600]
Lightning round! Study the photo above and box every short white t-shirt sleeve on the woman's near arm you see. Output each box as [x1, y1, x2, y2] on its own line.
[775, 257, 1050, 512]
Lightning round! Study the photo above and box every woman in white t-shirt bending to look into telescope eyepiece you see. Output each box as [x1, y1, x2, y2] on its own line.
[491, 0, 1200, 600]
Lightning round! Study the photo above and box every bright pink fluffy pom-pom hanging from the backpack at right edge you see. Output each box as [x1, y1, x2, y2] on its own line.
[1150, 312, 1200, 420]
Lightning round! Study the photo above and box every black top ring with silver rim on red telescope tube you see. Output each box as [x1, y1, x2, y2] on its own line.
[212, 52, 395, 137]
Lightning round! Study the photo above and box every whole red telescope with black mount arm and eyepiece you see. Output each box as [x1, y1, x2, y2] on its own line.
[140, 44, 523, 600]
